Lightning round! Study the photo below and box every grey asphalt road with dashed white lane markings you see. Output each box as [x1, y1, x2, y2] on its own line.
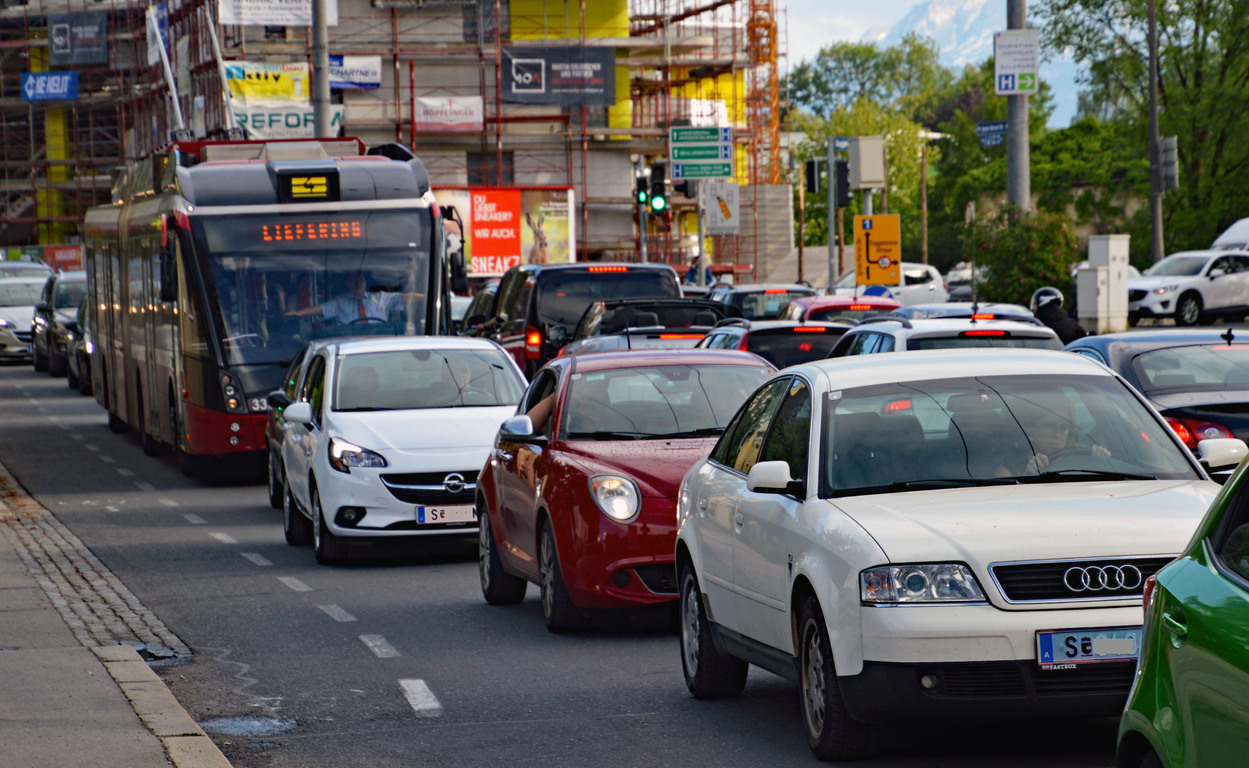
[0, 366, 1117, 768]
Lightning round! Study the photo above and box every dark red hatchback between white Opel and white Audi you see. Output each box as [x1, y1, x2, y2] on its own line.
[477, 350, 774, 632]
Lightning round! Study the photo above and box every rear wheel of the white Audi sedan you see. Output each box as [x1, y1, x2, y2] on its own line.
[678, 561, 749, 698]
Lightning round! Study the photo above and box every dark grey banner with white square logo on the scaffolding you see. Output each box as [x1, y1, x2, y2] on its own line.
[503, 46, 616, 106]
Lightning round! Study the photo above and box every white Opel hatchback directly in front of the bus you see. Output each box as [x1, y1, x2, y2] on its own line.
[281, 337, 525, 563]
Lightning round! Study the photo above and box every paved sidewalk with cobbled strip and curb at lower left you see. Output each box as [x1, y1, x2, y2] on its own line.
[0, 466, 230, 768]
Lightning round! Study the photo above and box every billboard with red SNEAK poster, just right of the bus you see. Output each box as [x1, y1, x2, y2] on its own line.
[433, 187, 577, 277]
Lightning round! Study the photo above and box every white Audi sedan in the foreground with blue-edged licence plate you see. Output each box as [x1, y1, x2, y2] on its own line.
[676, 348, 1245, 759]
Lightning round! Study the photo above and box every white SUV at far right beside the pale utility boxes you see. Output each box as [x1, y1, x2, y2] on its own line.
[1128, 251, 1249, 326]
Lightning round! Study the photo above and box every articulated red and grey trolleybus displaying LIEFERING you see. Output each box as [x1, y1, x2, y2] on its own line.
[84, 139, 462, 473]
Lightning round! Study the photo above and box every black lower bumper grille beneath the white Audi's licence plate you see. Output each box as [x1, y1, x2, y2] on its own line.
[937, 662, 1137, 698]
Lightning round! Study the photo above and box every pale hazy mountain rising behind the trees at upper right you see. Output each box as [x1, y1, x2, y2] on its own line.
[864, 0, 1078, 127]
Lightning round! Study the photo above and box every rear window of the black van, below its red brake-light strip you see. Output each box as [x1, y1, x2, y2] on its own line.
[537, 268, 681, 330]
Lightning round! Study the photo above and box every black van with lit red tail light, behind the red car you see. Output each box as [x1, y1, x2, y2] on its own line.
[477, 262, 681, 376]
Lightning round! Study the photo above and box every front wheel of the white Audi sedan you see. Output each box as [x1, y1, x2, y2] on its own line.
[798, 596, 872, 761]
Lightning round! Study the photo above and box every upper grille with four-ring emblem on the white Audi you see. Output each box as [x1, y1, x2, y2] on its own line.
[989, 556, 1174, 603]
